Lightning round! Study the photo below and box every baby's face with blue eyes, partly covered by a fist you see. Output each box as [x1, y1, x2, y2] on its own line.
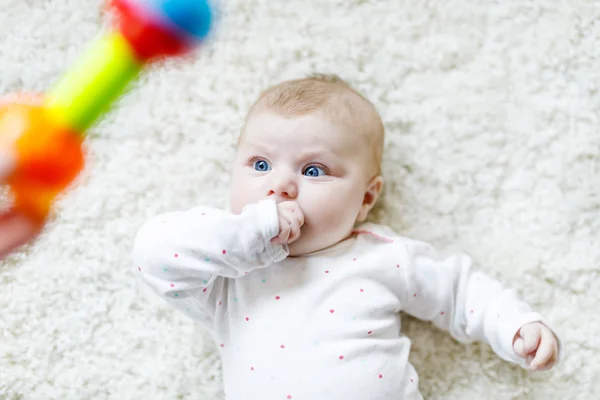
[230, 111, 371, 256]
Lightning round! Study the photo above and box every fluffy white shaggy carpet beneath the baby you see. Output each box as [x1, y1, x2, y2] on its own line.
[0, 0, 600, 400]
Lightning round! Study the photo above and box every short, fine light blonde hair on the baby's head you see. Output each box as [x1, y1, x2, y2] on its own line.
[241, 74, 384, 175]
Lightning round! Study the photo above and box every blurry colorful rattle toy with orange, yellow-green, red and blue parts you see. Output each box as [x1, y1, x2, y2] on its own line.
[0, 0, 212, 224]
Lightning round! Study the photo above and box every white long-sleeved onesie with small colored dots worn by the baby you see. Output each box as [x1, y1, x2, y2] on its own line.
[133, 200, 542, 400]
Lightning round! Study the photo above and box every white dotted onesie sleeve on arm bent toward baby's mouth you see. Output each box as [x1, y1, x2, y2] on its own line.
[132, 199, 288, 319]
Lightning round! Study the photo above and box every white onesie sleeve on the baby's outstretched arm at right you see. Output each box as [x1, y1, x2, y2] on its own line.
[403, 238, 562, 368]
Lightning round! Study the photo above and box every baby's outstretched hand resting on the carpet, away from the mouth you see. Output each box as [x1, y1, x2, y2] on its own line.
[513, 322, 558, 371]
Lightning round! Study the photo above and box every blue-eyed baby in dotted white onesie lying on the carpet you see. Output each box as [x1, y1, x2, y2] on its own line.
[133, 76, 560, 400]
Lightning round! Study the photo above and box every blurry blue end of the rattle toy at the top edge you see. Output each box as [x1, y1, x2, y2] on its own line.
[150, 0, 213, 39]
